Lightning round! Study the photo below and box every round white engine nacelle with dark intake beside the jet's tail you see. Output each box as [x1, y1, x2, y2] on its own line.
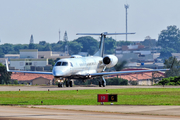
[103, 55, 118, 68]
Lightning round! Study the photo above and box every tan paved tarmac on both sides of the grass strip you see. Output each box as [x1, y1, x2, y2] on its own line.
[0, 86, 180, 120]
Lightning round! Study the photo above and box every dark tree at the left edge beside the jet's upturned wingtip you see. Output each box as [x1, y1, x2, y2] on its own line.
[0, 63, 11, 84]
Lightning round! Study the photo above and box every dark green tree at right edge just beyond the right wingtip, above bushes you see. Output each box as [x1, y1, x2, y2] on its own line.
[164, 57, 180, 77]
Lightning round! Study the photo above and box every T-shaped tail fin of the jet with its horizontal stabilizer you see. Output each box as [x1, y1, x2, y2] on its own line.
[76, 32, 135, 57]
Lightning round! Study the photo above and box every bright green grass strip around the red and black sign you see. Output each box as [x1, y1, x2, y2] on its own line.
[0, 88, 180, 105]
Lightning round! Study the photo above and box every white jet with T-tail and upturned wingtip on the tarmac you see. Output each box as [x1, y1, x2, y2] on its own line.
[6, 32, 167, 87]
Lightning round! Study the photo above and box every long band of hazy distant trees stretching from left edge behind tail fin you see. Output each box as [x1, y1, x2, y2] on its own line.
[0, 36, 130, 58]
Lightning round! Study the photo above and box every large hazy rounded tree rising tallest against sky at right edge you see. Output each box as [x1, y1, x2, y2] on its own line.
[157, 25, 180, 52]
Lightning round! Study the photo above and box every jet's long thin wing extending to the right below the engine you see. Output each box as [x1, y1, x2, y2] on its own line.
[90, 69, 169, 76]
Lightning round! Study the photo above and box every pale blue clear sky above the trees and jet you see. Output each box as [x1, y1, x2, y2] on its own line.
[0, 0, 180, 44]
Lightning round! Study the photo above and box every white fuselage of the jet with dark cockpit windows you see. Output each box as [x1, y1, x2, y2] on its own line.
[52, 56, 102, 79]
